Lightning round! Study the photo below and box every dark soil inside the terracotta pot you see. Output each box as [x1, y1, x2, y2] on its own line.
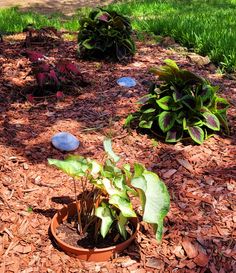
[56, 215, 134, 249]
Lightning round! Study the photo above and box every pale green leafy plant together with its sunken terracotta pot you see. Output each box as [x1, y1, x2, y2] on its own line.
[48, 139, 170, 261]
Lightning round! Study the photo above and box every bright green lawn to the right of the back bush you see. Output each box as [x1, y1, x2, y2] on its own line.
[110, 0, 236, 71]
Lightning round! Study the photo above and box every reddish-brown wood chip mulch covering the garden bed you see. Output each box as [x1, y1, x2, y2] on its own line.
[0, 33, 236, 273]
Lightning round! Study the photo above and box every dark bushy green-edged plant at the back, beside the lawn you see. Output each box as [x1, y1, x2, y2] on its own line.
[78, 9, 135, 61]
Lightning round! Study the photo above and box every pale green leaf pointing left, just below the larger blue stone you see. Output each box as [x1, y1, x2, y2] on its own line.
[48, 156, 89, 177]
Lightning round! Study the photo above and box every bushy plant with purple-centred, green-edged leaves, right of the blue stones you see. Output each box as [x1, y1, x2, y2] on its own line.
[126, 59, 229, 144]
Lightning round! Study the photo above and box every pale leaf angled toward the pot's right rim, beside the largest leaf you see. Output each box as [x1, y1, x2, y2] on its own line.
[109, 194, 136, 217]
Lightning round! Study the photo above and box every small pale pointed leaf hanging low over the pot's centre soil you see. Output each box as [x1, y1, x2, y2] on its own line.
[95, 202, 114, 238]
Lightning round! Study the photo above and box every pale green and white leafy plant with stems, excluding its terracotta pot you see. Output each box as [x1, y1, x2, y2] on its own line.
[48, 139, 170, 241]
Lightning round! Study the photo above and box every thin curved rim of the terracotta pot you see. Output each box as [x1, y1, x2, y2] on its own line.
[50, 202, 139, 253]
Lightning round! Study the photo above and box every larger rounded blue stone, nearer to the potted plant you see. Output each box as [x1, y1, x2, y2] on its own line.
[51, 132, 79, 152]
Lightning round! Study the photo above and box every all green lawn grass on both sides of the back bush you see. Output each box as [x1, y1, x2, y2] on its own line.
[0, 0, 236, 71]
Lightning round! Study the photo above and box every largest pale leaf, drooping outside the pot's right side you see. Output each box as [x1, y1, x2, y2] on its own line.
[131, 168, 170, 241]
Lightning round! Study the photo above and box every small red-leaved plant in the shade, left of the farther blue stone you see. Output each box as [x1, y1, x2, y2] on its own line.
[25, 50, 85, 96]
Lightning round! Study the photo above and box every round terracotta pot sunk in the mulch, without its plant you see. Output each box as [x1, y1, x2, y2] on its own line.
[50, 202, 139, 262]
